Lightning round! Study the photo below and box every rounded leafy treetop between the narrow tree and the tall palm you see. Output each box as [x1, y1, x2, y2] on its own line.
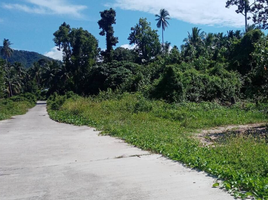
[128, 18, 161, 61]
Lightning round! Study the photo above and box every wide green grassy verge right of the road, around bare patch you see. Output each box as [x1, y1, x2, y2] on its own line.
[49, 94, 268, 199]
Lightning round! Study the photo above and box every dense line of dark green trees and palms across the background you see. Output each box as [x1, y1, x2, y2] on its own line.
[0, 4, 268, 103]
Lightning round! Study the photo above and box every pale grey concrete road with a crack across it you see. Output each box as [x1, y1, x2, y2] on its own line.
[0, 102, 233, 200]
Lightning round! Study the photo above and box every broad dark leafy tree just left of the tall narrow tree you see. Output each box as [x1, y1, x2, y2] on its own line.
[54, 23, 98, 94]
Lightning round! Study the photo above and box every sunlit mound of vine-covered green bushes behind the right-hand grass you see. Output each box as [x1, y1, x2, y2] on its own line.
[151, 64, 242, 102]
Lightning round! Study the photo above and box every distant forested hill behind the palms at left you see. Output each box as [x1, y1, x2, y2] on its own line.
[0, 46, 53, 68]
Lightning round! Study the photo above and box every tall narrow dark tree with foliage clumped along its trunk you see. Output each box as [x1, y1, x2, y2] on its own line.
[98, 8, 118, 61]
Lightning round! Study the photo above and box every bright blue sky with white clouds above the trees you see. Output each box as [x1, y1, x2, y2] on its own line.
[0, 0, 250, 59]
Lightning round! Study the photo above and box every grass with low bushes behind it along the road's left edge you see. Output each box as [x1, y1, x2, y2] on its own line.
[0, 93, 36, 120]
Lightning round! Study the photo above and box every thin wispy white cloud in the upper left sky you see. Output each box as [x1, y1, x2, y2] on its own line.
[2, 0, 87, 18]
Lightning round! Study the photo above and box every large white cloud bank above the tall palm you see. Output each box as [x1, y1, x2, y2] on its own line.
[113, 0, 249, 27]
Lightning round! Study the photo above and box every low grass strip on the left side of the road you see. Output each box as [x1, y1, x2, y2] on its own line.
[0, 96, 34, 120]
